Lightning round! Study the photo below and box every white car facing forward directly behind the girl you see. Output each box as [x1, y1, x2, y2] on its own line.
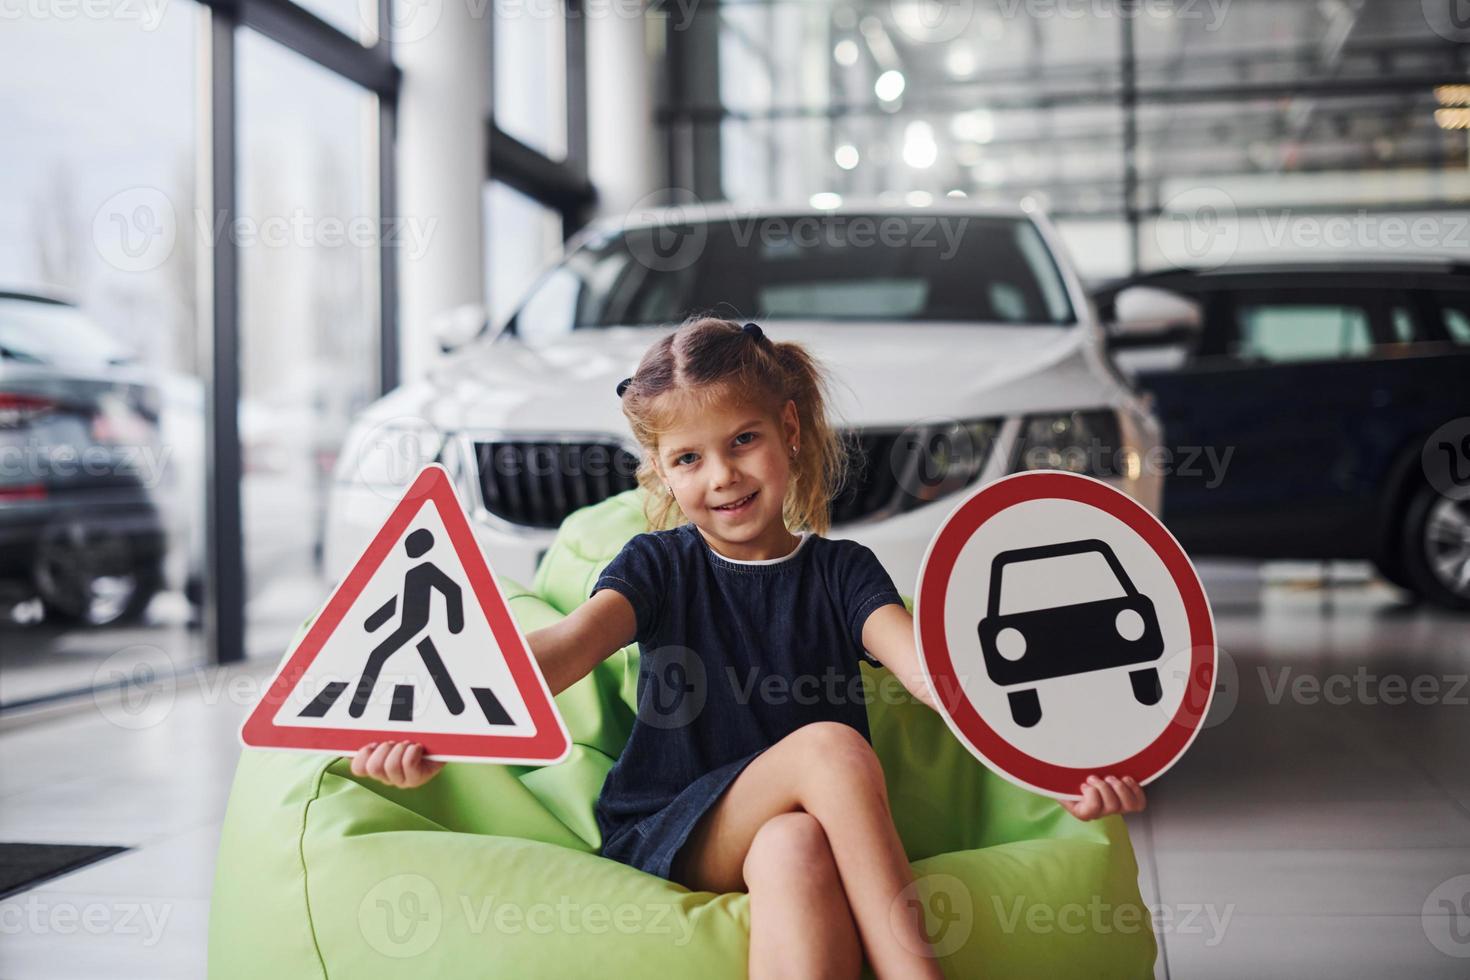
[326, 200, 1161, 595]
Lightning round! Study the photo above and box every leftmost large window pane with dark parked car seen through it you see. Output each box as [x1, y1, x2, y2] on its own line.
[0, 3, 209, 702]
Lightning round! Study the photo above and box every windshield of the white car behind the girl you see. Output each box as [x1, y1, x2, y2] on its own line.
[510, 213, 1075, 341]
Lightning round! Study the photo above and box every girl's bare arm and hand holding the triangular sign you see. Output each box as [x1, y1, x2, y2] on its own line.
[351, 589, 638, 789]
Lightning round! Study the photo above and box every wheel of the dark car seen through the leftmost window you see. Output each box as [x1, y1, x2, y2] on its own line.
[32, 522, 163, 626]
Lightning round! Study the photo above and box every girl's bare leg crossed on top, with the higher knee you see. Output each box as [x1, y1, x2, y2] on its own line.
[675, 721, 942, 979]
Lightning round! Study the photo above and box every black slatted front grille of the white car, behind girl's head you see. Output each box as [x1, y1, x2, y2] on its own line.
[473, 420, 998, 529]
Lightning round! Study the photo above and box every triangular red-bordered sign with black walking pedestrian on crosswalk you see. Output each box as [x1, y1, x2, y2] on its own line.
[240, 464, 572, 764]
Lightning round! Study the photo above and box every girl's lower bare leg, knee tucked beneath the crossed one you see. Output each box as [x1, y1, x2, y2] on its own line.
[742, 811, 863, 980]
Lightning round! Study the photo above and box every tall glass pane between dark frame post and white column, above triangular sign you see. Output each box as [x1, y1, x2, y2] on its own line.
[239, 31, 379, 657]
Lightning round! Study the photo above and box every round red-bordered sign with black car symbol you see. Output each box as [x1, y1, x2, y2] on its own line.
[914, 472, 1216, 799]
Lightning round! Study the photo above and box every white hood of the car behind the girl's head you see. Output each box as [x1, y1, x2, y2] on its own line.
[368, 322, 1125, 435]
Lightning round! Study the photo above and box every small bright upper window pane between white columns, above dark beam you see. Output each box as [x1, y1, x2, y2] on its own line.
[492, 0, 566, 160]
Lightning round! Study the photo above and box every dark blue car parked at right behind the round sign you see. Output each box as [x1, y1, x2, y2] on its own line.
[1094, 262, 1470, 610]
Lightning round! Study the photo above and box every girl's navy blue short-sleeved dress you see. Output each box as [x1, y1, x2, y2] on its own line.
[591, 525, 903, 879]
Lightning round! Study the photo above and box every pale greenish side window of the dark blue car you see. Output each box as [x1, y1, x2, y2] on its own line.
[1230, 303, 1373, 361]
